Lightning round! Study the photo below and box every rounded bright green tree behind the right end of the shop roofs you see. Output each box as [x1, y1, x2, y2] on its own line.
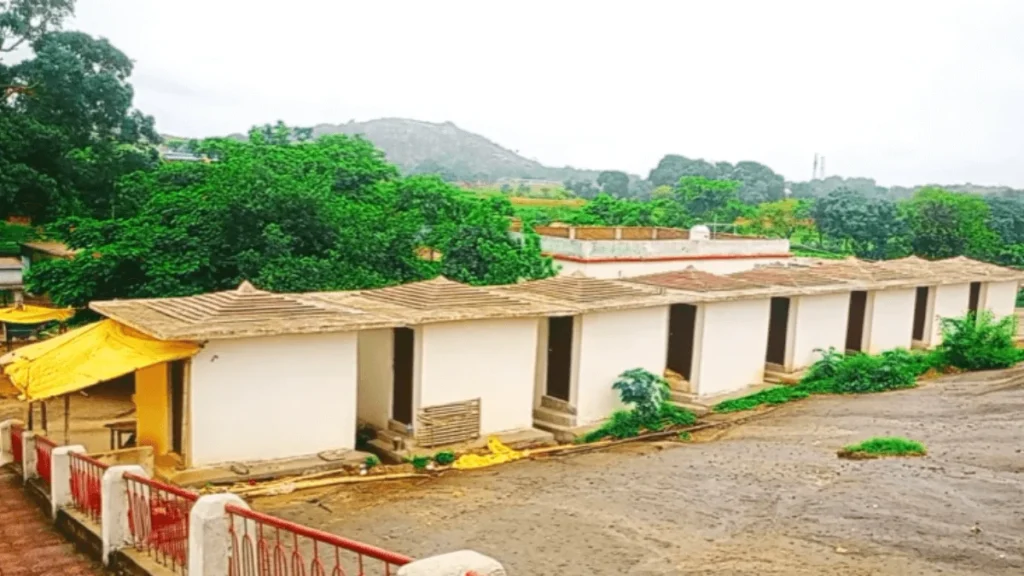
[902, 188, 998, 259]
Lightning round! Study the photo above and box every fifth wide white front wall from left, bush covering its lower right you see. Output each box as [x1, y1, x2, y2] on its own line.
[785, 292, 850, 371]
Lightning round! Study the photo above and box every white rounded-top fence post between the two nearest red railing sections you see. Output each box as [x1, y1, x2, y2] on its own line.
[188, 494, 249, 576]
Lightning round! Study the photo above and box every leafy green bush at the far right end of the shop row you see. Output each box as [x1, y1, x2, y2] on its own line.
[936, 311, 1024, 370]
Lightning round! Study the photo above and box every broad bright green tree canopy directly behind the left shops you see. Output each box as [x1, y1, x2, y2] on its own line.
[28, 130, 552, 305]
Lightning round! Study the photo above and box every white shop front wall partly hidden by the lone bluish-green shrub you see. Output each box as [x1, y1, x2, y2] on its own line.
[572, 306, 669, 425]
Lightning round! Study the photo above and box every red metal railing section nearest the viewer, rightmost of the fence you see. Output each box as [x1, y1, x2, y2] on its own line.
[224, 504, 413, 576]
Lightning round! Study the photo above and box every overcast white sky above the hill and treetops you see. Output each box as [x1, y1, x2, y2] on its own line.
[69, 0, 1024, 188]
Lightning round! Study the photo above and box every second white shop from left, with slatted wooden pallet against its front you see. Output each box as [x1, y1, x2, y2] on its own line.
[309, 278, 559, 449]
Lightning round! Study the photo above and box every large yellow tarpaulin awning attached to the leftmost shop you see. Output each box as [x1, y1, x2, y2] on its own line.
[4, 320, 199, 402]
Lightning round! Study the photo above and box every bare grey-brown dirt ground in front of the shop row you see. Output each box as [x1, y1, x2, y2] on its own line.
[254, 366, 1024, 576]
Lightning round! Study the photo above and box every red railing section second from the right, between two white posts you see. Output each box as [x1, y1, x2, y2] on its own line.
[124, 474, 199, 574]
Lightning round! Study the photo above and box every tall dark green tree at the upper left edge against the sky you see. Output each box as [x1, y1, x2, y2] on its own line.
[0, 0, 159, 222]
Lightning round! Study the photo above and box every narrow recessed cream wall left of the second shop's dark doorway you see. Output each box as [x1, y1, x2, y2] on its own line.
[357, 328, 394, 428]
